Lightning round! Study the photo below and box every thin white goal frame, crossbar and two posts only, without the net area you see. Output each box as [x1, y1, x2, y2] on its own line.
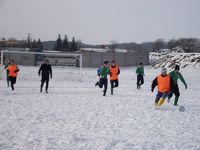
[0, 50, 83, 80]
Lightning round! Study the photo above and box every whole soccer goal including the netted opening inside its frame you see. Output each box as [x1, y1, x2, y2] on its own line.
[0, 50, 82, 80]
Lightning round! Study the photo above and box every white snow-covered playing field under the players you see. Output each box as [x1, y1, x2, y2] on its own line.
[0, 66, 200, 150]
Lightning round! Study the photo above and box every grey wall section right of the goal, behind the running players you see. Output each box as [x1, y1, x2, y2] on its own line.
[81, 51, 149, 67]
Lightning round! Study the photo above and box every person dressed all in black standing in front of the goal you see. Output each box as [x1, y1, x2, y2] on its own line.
[38, 59, 52, 93]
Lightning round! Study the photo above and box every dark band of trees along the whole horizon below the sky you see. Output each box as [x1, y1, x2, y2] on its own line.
[0, 34, 200, 53]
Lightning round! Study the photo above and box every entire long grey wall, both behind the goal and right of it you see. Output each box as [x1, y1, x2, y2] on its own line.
[1, 50, 149, 68]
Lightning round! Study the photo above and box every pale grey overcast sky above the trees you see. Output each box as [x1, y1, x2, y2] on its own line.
[0, 0, 200, 44]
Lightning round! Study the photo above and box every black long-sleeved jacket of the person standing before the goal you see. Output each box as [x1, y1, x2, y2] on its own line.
[38, 64, 52, 79]
